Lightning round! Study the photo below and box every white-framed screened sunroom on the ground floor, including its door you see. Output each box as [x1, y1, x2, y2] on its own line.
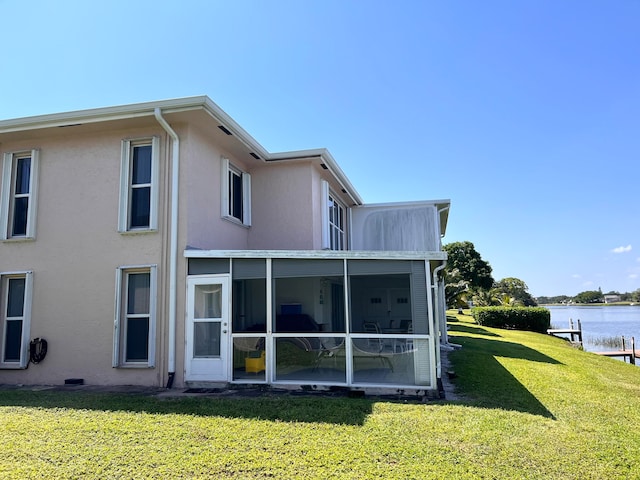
[185, 250, 445, 390]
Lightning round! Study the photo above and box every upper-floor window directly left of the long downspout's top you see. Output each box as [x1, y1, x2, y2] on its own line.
[118, 137, 159, 232]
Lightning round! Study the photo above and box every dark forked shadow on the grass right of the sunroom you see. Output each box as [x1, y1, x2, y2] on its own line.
[449, 336, 560, 419]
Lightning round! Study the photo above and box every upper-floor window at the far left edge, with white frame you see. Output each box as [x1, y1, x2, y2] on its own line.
[0, 150, 38, 240]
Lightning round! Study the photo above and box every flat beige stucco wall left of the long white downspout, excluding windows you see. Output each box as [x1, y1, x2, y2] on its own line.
[0, 123, 167, 385]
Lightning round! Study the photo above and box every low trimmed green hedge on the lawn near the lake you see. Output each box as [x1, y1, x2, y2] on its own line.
[471, 307, 551, 333]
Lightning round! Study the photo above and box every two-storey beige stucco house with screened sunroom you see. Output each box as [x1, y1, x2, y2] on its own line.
[0, 96, 449, 391]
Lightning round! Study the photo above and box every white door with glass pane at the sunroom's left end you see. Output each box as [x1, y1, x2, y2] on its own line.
[185, 275, 229, 382]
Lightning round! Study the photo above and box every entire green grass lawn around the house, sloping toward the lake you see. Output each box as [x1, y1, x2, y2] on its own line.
[0, 315, 640, 479]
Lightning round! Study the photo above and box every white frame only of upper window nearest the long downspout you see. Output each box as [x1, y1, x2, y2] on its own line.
[118, 136, 160, 233]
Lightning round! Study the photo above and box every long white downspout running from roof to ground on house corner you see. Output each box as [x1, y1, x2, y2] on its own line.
[154, 107, 180, 388]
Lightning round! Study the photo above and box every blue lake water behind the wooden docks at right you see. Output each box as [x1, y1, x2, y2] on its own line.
[545, 305, 640, 352]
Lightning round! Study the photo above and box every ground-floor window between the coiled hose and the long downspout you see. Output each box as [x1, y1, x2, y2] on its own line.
[113, 266, 156, 367]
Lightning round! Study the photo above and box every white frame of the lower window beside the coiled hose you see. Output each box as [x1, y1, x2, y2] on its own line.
[0, 271, 33, 369]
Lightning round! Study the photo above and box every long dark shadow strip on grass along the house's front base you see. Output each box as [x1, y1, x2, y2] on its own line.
[0, 389, 375, 425]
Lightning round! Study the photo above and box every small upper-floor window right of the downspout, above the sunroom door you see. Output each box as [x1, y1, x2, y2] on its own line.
[221, 158, 251, 227]
